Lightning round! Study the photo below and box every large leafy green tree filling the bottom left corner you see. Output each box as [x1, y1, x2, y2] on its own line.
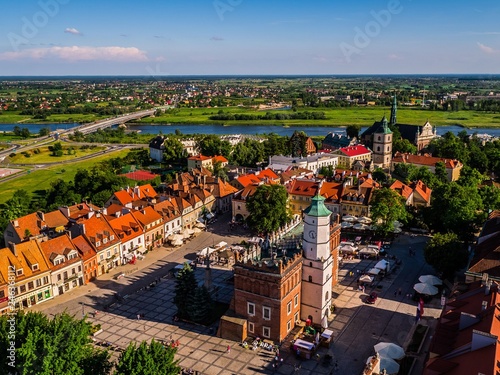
[0, 312, 112, 375]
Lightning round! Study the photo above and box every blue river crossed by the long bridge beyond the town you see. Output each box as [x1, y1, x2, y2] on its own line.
[0, 124, 500, 137]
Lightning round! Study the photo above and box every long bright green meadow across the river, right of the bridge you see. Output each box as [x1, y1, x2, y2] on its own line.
[141, 107, 500, 128]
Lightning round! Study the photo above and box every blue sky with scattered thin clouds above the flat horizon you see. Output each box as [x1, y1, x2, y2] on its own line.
[0, 0, 500, 75]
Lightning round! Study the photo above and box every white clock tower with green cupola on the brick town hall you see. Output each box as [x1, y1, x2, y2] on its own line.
[301, 195, 333, 324]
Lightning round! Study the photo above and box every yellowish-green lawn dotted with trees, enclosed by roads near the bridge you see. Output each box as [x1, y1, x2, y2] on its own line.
[9, 142, 104, 164]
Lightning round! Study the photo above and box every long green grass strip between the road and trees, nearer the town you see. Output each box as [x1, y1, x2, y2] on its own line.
[0, 150, 129, 204]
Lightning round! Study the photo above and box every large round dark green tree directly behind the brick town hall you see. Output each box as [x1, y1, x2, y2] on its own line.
[247, 185, 290, 234]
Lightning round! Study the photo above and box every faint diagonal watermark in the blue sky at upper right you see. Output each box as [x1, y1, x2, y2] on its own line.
[340, 0, 404, 63]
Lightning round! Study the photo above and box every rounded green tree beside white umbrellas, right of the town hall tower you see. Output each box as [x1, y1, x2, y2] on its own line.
[370, 188, 406, 235]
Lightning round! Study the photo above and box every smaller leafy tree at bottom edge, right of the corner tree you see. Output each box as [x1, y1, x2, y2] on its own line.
[114, 339, 181, 375]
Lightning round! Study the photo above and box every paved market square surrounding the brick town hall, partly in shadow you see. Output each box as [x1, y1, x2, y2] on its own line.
[30, 233, 440, 375]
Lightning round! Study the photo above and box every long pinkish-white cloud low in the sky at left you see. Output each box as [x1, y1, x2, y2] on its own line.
[0, 46, 148, 62]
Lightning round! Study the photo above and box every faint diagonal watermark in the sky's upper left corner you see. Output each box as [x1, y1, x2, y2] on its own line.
[7, 0, 69, 52]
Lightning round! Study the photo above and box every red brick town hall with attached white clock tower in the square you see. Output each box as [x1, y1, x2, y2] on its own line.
[218, 195, 340, 342]
